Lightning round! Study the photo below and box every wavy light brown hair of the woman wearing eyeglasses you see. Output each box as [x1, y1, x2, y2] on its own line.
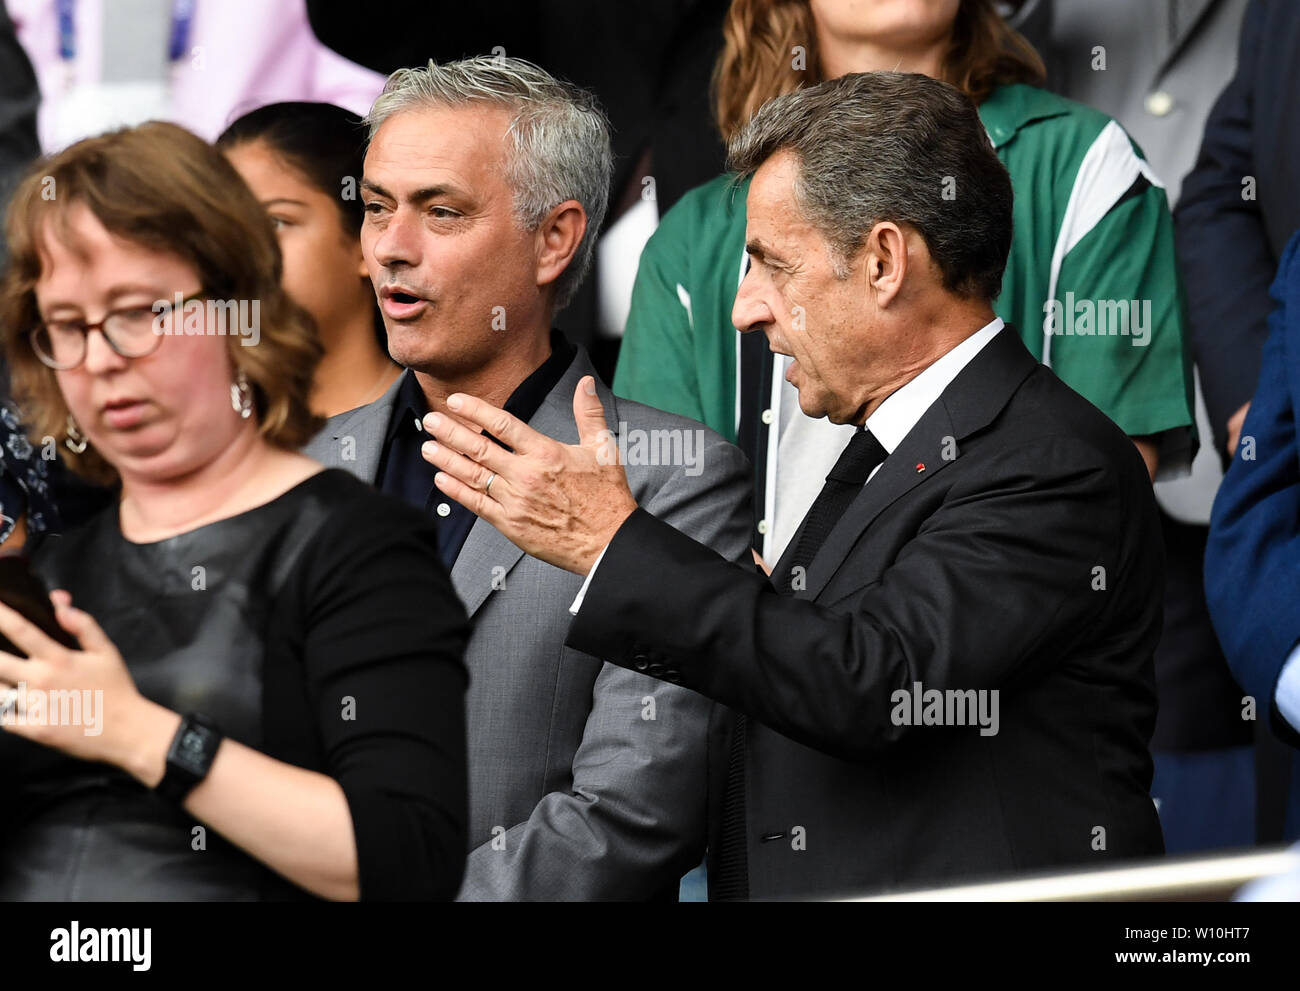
[0, 121, 321, 482]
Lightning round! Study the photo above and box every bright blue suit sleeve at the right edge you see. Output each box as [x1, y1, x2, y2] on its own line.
[1205, 234, 1300, 744]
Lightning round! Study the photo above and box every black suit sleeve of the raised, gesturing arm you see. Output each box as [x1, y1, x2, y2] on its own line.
[568, 438, 1133, 761]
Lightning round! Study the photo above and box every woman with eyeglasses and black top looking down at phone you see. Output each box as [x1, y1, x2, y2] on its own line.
[0, 122, 468, 900]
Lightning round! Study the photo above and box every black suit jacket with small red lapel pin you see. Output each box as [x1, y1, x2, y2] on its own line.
[568, 329, 1164, 897]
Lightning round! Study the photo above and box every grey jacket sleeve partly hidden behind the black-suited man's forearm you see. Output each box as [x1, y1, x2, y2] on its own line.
[460, 440, 753, 901]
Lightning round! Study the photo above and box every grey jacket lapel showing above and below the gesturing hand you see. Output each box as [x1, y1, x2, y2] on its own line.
[451, 347, 618, 616]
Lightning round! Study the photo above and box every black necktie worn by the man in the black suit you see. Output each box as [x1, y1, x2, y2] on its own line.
[709, 428, 888, 901]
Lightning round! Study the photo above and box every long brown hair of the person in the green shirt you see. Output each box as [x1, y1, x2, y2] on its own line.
[714, 0, 1047, 142]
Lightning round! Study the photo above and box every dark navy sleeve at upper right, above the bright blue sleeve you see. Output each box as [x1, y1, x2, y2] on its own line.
[1174, 0, 1277, 451]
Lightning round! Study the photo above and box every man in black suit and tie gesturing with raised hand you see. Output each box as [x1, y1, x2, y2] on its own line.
[425, 73, 1164, 897]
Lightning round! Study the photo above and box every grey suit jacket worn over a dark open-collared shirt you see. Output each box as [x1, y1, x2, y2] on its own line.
[304, 350, 753, 900]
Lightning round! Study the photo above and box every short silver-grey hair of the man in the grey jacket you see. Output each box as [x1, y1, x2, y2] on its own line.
[365, 55, 614, 310]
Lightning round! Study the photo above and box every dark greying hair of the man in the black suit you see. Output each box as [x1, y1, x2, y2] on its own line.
[728, 73, 1013, 300]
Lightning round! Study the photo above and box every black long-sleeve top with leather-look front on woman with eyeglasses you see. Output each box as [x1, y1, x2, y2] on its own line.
[0, 469, 468, 900]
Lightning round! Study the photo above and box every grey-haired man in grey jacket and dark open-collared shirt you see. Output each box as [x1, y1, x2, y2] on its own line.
[307, 57, 751, 900]
